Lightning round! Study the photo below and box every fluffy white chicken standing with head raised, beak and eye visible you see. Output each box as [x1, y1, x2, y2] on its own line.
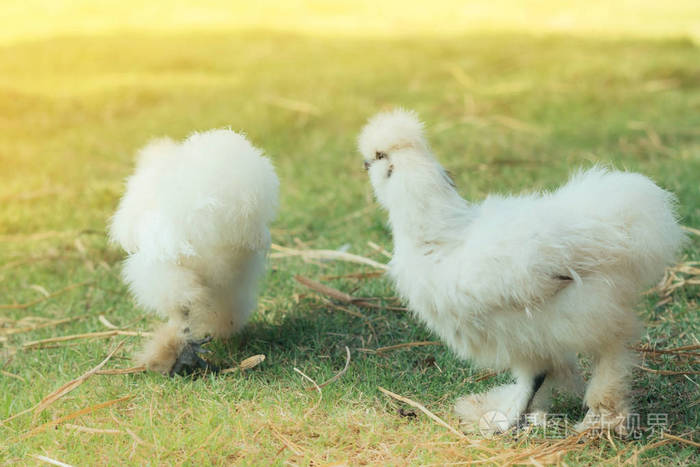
[358, 110, 683, 432]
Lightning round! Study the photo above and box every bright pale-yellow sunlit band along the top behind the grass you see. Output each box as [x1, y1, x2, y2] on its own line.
[0, 0, 700, 42]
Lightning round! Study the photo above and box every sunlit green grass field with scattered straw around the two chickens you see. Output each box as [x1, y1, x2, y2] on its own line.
[0, 0, 700, 465]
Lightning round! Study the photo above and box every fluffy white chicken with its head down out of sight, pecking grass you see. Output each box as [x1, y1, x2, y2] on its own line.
[110, 130, 279, 374]
